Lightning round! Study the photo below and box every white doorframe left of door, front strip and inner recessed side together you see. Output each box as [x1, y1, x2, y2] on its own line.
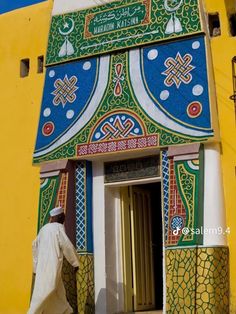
[93, 162, 124, 314]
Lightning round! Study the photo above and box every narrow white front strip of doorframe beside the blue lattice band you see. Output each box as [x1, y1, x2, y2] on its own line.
[93, 162, 107, 314]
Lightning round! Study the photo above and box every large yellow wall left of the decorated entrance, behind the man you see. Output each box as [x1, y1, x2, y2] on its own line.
[0, 1, 52, 314]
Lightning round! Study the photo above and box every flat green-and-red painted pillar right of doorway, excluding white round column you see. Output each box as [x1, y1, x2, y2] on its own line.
[162, 144, 203, 313]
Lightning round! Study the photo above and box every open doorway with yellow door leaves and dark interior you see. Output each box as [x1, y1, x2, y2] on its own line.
[121, 182, 163, 312]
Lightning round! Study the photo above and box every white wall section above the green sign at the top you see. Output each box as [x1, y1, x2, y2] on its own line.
[52, 0, 115, 15]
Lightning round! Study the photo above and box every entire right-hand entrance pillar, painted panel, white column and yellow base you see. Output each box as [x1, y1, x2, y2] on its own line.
[162, 144, 229, 313]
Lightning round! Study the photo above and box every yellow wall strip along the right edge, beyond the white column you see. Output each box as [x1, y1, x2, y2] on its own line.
[205, 0, 236, 314]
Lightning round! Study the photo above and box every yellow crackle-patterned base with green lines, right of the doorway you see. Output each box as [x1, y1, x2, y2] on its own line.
[165, 247, 229, 314]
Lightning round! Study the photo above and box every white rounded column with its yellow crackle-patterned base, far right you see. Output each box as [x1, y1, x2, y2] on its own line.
[196, 143, 229, 313]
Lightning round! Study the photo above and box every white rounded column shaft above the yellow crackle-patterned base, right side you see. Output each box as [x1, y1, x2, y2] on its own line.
[203, 144, 227, 246]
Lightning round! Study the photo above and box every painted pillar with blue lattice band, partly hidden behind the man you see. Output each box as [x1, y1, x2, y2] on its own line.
[35, 160, 94, 314]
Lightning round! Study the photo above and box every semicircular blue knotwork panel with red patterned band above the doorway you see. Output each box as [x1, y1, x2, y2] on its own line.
[77, 110, 159, 156]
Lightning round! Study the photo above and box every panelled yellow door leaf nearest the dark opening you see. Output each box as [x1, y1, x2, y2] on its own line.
[131, 187, 155, 311]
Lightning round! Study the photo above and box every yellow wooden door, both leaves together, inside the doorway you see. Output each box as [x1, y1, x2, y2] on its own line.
[121, 186, 155, 311]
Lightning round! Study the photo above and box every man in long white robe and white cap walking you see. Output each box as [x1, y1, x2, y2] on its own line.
[28, 207, 79, 314]
